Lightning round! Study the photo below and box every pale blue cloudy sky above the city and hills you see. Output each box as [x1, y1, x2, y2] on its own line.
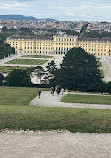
[0, 0, 111, 22]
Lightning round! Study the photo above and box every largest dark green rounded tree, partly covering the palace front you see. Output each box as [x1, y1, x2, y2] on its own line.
[52, 48, 101, 91]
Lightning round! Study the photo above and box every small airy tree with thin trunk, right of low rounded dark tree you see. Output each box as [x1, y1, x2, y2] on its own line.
[33, 66, 44, 84]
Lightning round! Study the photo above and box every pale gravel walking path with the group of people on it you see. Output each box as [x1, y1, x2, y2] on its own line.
[30, 91, 111, 109]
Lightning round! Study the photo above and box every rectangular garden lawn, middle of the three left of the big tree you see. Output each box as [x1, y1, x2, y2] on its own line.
[6, 59, 48, 65]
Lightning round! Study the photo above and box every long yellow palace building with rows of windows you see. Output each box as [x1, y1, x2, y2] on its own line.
[6, 35, 111, 56]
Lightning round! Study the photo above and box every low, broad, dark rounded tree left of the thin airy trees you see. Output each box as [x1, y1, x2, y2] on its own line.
[5, 69, 32, 87]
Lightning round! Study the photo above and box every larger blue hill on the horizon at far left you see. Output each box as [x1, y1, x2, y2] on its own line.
[0, 15, 37, 20]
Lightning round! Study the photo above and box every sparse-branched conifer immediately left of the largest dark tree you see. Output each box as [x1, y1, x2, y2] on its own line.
[44, 60, 57, 84]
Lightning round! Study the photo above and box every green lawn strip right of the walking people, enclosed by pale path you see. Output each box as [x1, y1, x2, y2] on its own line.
[61, 94, 111, 105]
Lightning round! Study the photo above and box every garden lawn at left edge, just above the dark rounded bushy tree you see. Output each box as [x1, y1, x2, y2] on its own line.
[0, 66, 27, 73]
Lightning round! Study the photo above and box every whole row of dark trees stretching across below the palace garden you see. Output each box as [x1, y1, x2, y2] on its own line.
[1, 48, 111, 93]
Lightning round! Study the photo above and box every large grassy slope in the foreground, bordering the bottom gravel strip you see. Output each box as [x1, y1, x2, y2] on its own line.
[0, 87, 111, 133]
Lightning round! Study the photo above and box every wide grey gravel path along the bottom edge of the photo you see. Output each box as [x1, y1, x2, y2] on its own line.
[0, 132, 111, 158]
